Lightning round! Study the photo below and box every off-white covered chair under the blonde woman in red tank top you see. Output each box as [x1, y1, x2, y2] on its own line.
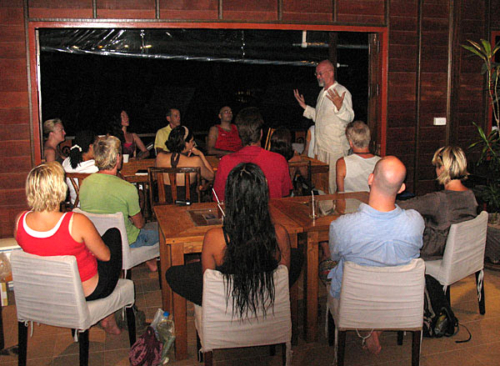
[11, 251, 135, 366]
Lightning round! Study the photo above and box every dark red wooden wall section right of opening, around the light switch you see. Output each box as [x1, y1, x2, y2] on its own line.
[387, 0, 488, 194]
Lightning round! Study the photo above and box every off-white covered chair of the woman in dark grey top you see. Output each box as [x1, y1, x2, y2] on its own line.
[425, 211, 488, 315]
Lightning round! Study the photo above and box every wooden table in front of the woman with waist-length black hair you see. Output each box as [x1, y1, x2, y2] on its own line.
[154, 202, 302, 360]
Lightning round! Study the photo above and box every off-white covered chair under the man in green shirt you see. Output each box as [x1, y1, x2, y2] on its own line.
[73, 208, 160, 279]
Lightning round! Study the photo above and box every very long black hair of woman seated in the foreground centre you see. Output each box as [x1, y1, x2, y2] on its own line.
[220, 163, 280, 317]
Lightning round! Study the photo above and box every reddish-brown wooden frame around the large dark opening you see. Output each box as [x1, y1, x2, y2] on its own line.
[27, 19, 389, 164]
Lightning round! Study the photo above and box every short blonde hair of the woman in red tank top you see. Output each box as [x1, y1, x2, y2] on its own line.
[26, 161, 68, 212]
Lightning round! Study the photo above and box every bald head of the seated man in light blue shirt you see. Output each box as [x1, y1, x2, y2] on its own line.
[369, 156, 406, 197]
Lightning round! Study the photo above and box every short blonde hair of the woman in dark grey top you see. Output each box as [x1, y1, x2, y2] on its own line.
[432, 146, 469, 185]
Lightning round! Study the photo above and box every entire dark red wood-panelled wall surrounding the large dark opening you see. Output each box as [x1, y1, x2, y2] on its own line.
[0, 0, 492, 237]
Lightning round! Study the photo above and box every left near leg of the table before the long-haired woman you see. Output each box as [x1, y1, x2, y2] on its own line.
[170, 244, 187, 360]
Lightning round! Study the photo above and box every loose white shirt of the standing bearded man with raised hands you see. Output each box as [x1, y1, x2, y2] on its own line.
[304, 82, 354, 155]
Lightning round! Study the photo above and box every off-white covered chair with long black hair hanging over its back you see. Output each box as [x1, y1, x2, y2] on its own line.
[195, 265, 292, 366]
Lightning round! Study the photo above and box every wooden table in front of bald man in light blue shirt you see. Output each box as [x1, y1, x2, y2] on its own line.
[270, 192, 369, 342]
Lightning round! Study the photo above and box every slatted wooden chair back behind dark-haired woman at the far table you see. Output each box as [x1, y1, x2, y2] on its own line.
[148, 167, 201, 208]
